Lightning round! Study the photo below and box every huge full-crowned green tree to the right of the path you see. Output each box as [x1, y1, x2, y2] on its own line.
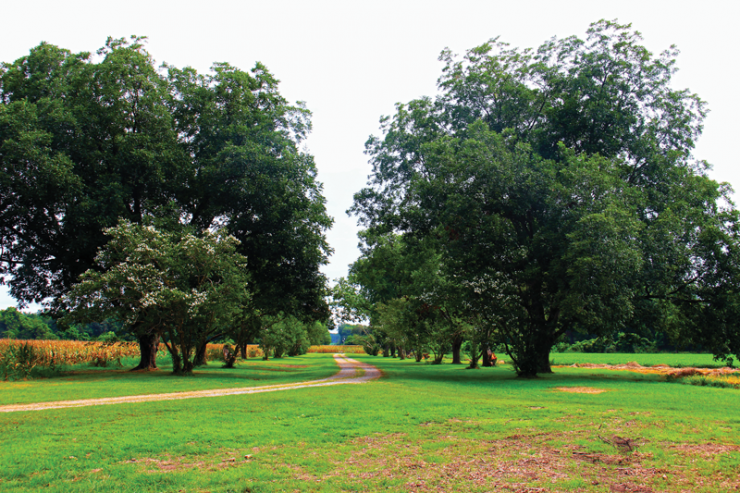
[351, 21, 738, 376]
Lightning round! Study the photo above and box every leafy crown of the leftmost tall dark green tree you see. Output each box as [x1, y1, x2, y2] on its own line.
[0, 38, 179, 303]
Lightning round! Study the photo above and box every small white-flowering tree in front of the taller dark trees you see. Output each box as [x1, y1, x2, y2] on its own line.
[64, 221, 250, 374]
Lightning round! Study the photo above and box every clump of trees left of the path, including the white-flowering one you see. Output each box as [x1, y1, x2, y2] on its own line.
[0, 37, 332, 371]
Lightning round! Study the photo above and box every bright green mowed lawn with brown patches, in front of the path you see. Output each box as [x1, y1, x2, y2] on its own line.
[0, 355, 740, 493]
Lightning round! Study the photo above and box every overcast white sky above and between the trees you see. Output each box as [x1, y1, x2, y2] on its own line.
[0, 0, 740, 309]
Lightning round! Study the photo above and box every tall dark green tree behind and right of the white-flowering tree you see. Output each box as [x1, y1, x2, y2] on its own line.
[169, 64, 332, 352]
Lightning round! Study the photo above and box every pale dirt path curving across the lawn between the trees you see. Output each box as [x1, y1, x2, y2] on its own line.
[0, 354, 380, 413]
